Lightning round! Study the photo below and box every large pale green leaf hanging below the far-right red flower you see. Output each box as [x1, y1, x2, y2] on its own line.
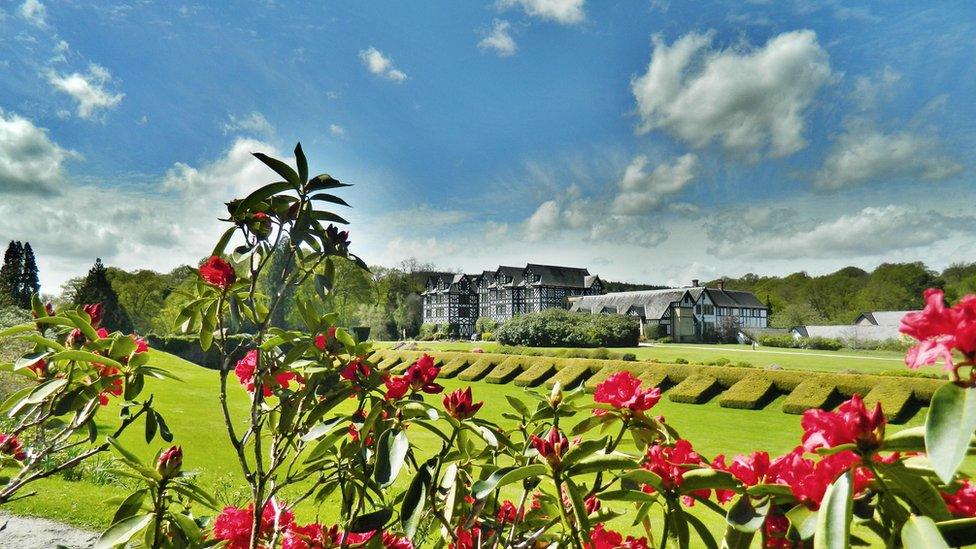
[925, 383, 976, 484]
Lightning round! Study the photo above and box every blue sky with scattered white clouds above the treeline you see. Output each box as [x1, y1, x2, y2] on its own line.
[0, 0, 976, 293]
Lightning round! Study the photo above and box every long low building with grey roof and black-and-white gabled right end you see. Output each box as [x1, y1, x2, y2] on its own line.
[570, 280, 769, 342]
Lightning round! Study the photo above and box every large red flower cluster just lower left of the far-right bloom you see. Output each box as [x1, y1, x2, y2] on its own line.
[800, 395, 887, 453]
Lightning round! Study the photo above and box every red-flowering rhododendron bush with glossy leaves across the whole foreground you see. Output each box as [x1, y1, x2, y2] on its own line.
[0, 146, 976, 549]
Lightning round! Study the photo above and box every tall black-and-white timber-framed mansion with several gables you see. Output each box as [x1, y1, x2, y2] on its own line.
[423, 263, 603, 337]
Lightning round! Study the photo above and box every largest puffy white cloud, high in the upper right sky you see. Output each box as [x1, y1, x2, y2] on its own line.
[631, 30, 834, 160]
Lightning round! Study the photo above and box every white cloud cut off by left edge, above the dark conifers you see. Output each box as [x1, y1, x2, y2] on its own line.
[0, 109, 81, 194]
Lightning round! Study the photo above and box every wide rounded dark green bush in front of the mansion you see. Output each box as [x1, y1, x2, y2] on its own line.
[495, 309, 638, 347]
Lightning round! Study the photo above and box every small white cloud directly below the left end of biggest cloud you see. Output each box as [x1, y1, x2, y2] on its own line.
[613, 154, 698, 215]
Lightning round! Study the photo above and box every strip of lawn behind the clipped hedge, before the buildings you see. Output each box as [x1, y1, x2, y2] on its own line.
[390, 341, 906, 374]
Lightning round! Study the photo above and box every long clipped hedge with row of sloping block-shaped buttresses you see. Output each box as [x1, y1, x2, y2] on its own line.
[372, 349, 945, 423]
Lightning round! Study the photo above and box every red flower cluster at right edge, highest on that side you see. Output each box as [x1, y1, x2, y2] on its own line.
[899, 288, 976, 370]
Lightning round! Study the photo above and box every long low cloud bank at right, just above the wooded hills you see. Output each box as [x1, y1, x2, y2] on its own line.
[709, 204, 976, 260]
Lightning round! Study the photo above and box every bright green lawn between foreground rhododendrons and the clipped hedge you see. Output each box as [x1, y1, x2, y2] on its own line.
[1, 343, 924, 544]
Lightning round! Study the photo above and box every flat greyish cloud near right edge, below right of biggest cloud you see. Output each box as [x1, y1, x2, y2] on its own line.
[813, 129, 963, 189]
